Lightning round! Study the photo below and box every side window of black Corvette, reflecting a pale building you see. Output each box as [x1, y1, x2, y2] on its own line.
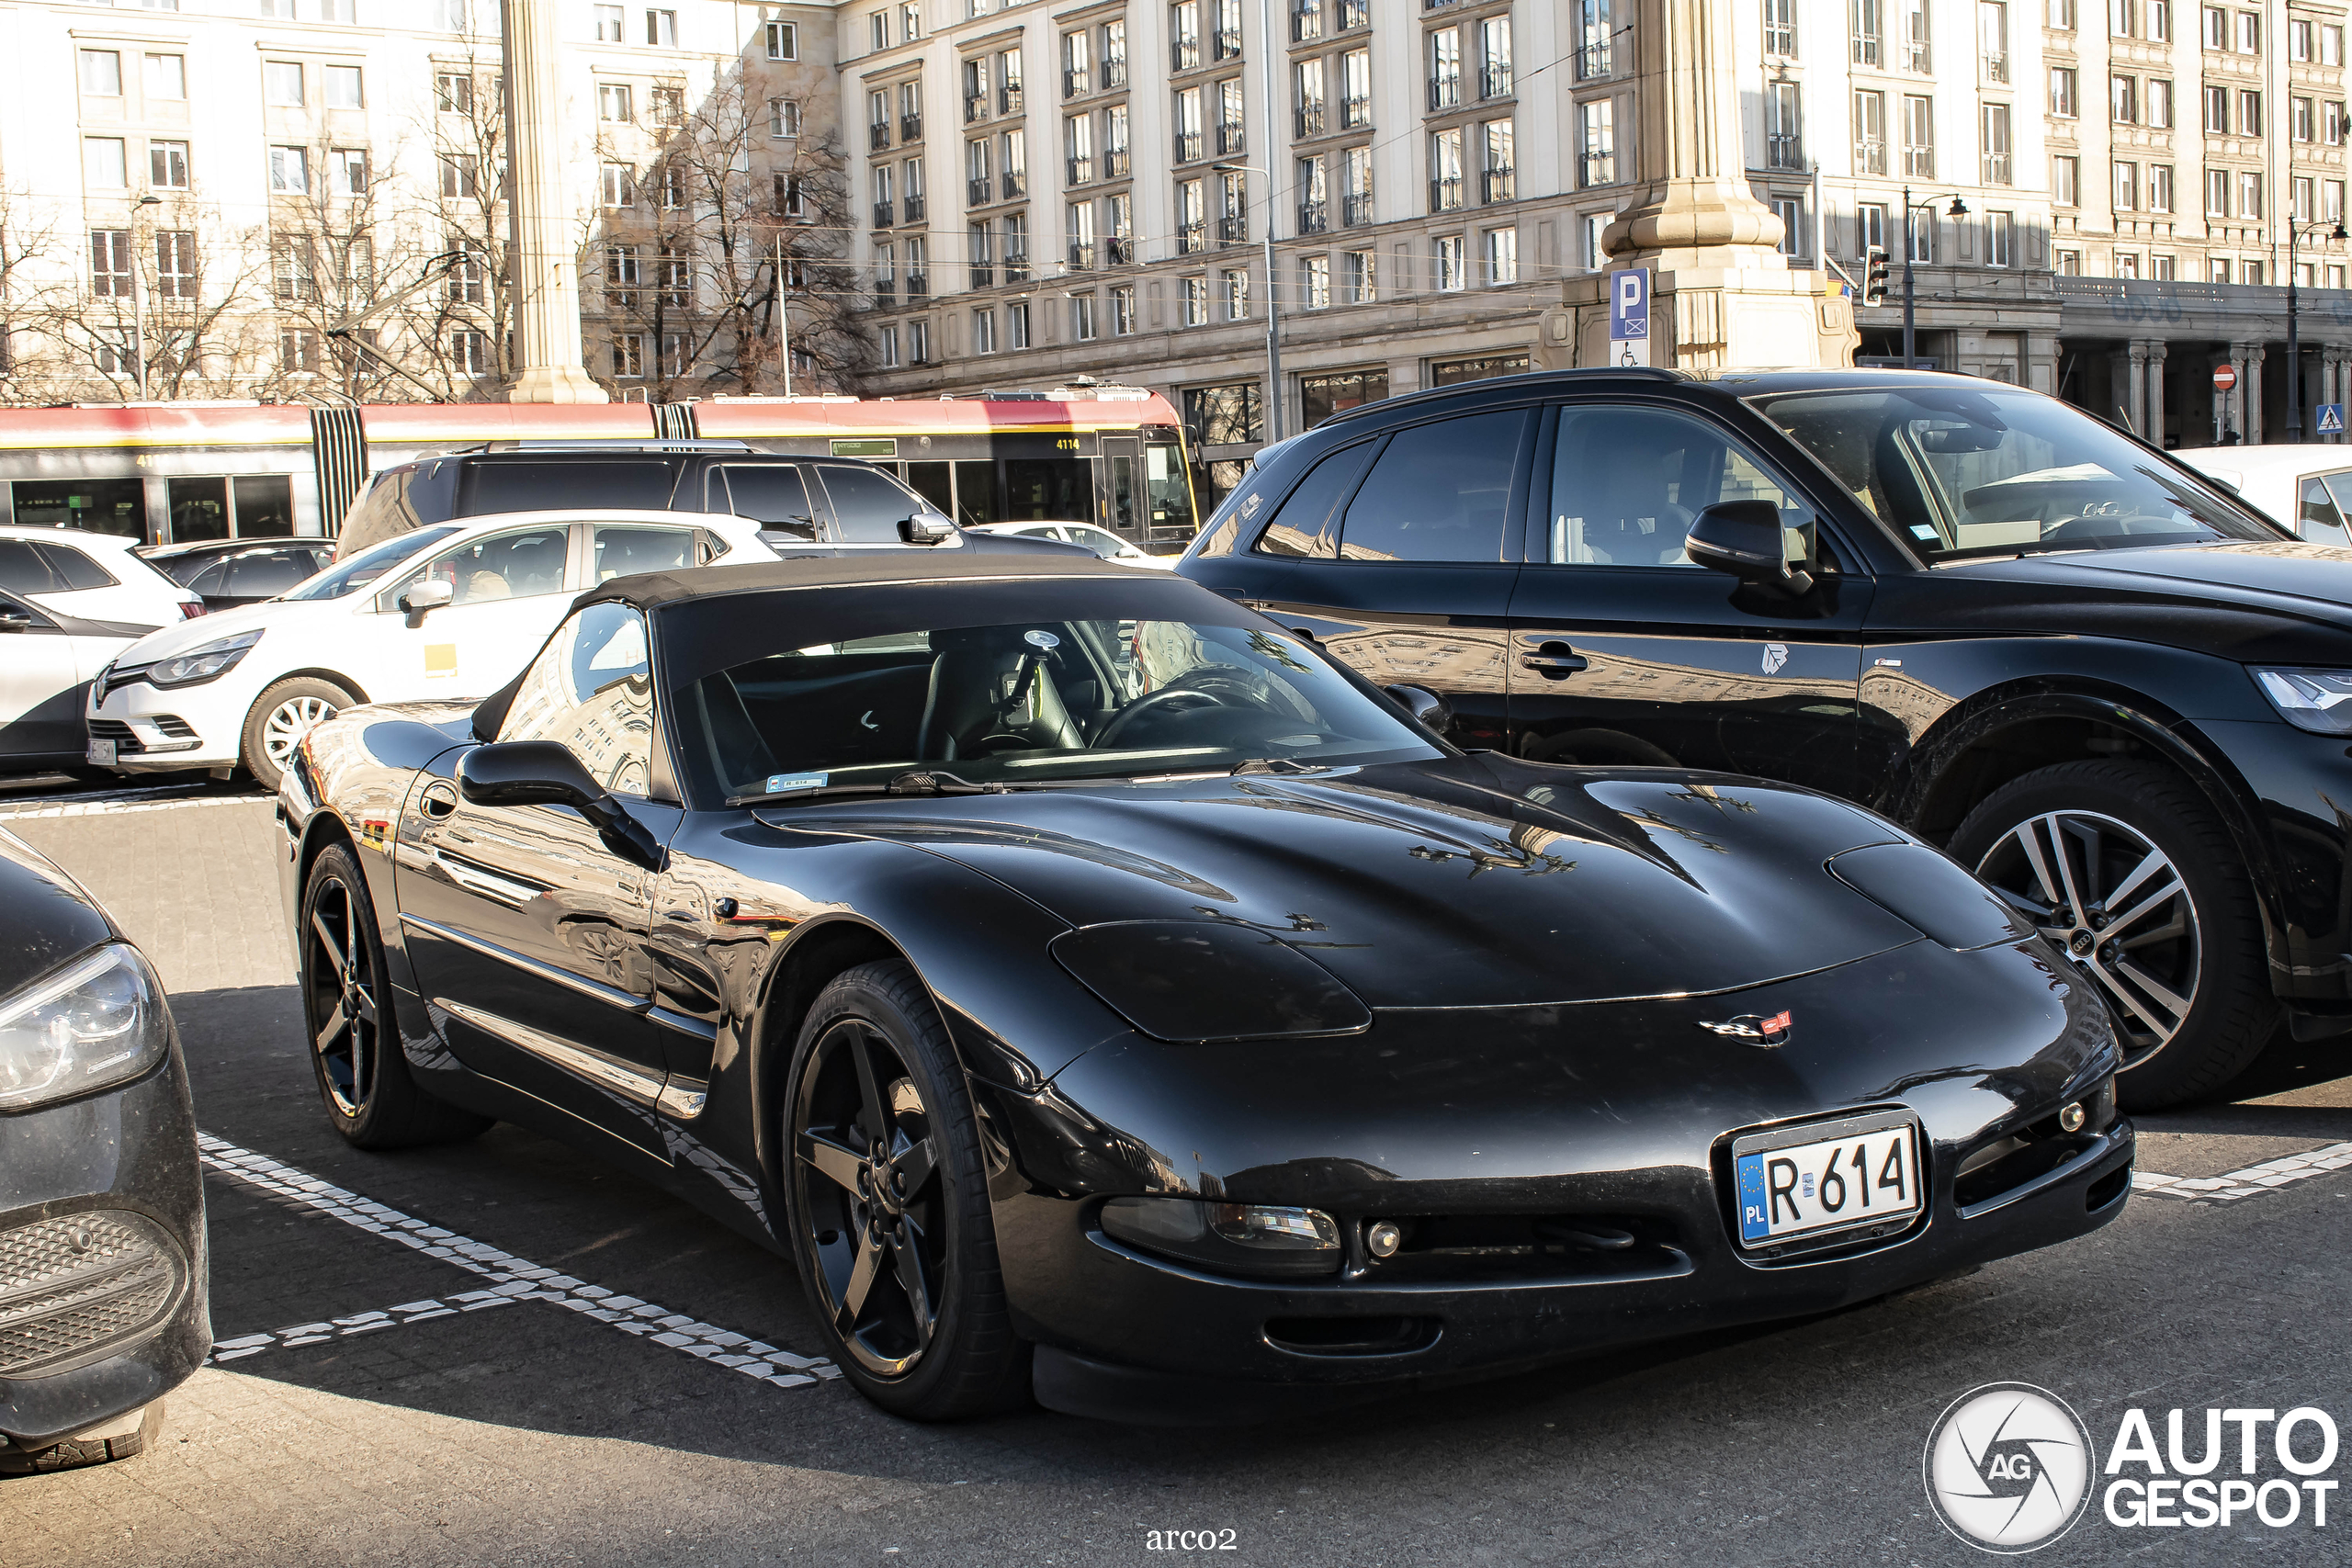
[499, 604, 654, 797]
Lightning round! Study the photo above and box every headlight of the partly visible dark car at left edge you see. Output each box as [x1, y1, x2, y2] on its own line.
[0, 942, 172, 1112]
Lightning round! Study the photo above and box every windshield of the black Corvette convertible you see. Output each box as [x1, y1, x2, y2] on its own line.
[677, 621, 1437, 799]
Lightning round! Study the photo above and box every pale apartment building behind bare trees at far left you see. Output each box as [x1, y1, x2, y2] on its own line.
[0, 0, 864, 402]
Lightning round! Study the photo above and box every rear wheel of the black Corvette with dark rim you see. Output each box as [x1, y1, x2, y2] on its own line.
[301, 844, 492, 1149]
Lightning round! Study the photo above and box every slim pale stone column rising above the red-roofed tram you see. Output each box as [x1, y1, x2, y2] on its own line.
[501, 0, 606, 402]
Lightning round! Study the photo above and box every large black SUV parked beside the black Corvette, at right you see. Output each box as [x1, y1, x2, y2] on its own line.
[1179, 369, 2352, 1107]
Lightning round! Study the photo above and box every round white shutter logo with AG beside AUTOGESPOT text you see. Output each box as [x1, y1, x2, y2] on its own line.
[1922, 1382, 2091, 1554]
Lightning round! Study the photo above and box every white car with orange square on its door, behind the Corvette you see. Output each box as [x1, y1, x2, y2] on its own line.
[89, 510, 776, 790]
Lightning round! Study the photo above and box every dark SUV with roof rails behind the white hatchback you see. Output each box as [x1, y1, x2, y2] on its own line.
[336, 440, 1080, 559]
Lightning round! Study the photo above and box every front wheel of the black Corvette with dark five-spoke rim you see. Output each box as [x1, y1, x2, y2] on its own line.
[783, 962, 1030, 1420]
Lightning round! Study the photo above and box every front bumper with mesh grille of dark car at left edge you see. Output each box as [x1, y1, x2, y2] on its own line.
[0, 1032, 211, 1448]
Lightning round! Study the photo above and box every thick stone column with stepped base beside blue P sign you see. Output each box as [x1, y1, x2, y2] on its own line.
[1566, 0, 1860, 369]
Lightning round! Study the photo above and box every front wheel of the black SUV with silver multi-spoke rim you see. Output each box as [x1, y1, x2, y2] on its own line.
[1950, 761, 2279, 1110]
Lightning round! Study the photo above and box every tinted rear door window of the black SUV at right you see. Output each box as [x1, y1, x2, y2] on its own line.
[1339, 409, 1526, 562]
